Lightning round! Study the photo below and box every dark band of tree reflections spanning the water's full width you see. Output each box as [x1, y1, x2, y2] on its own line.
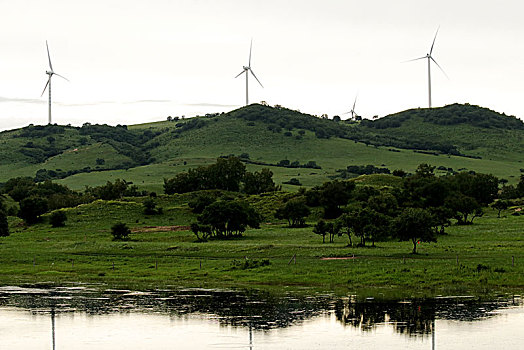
[0, 288, 522, 335]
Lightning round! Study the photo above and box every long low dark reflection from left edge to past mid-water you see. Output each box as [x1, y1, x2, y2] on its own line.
[0, 288, 332, 330]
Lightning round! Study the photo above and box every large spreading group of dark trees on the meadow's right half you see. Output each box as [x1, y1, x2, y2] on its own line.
[275, 164, 524, 252]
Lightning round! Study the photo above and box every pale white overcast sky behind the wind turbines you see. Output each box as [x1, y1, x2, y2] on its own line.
[0, 0, 524, 130]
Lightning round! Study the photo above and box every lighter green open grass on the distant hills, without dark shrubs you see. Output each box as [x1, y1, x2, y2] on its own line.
[0, 103, 524, 192]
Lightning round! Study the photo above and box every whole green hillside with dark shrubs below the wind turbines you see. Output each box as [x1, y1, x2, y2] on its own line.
[0, 104, 524, 191]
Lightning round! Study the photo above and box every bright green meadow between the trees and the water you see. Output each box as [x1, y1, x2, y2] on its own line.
[0, 194, 524, 297]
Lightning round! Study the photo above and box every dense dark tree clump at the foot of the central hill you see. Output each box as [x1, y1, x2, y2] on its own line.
[164, 157, 278, 194]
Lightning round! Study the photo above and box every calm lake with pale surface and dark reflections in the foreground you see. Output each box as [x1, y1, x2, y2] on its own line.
[0, 285, 524, 350]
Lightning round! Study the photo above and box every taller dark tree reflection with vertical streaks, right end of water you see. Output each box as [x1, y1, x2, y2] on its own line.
[334, 298, 522, 335]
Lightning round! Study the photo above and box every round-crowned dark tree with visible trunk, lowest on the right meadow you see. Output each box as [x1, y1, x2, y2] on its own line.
[395, 208, 437, 254]
